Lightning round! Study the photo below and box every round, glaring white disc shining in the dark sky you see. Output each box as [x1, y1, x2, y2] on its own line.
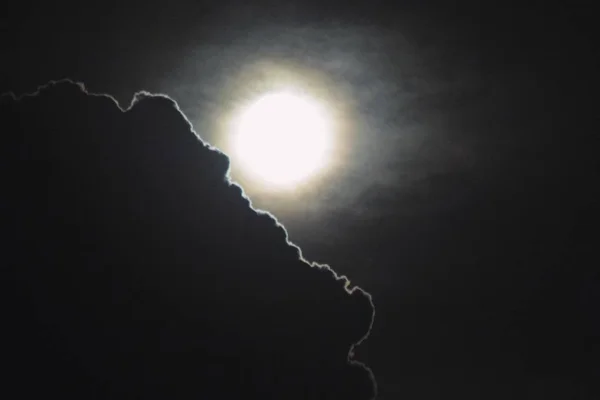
[233, 92, 332, 187]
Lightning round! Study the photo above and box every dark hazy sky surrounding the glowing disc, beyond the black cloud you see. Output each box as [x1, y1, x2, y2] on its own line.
[0, 0, 600, 400]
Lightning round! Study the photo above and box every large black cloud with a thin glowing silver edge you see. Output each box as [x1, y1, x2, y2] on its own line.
[0, 80, 376, 400]
